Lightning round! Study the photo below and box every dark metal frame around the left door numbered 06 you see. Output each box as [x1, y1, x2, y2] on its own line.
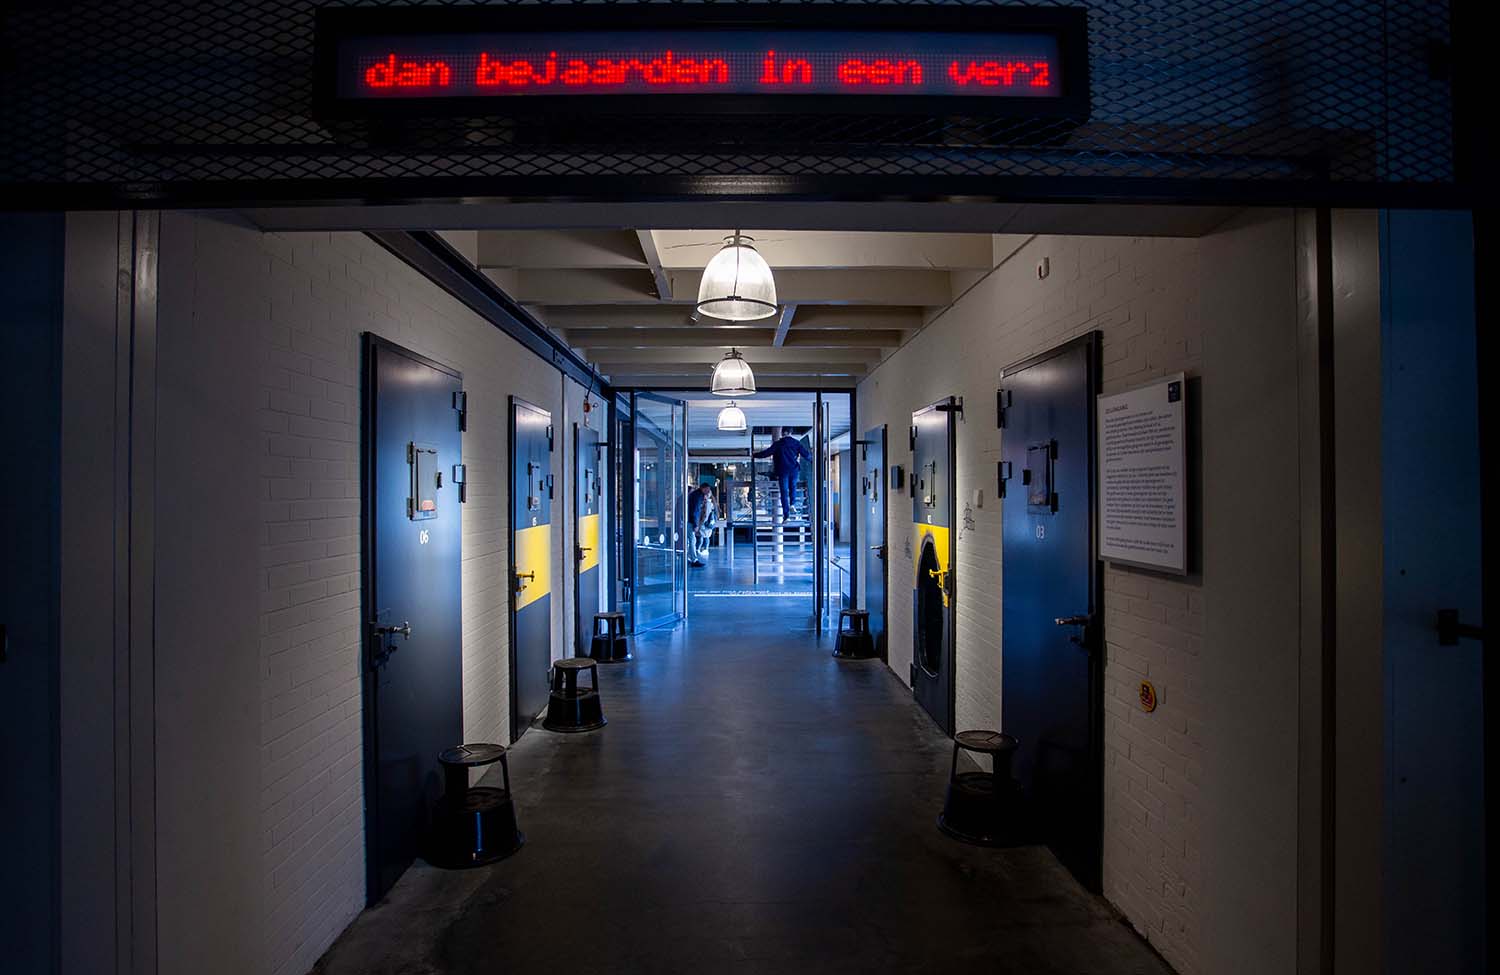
[360, 332, 464, 906]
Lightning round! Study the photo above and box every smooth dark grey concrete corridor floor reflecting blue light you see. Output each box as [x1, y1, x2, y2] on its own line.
[314, 599, 1170, 975]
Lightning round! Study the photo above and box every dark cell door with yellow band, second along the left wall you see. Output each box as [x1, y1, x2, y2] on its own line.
[510, 396, 557, 741]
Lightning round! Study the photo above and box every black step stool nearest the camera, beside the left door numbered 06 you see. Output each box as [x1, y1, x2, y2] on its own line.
[428, 744, 527, 869]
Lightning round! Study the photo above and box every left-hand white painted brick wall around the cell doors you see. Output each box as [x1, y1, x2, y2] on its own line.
[162, 215, 569, 975]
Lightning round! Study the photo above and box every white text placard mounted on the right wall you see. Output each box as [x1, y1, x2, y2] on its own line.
[1098, 372, 1188, 573]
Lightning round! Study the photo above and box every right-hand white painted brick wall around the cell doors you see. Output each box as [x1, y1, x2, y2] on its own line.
[858, 237, 1206, 974]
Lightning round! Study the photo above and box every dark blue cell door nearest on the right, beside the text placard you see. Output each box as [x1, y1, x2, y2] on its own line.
[1001, 333, 1104, 891]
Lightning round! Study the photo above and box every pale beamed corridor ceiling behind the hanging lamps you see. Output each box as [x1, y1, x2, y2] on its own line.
[465, 230, 1028, 389]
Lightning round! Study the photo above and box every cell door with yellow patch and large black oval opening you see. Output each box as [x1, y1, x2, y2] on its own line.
[909, 398, 957, 735]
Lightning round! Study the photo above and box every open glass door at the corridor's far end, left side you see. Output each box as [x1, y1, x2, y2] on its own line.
[632, 393, 687, 630]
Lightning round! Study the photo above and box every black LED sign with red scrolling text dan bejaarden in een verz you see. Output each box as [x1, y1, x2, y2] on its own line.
[318, 5, 1088, 116]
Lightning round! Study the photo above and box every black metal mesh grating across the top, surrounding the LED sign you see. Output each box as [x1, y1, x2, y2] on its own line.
[0, 0, 1455, 206]
